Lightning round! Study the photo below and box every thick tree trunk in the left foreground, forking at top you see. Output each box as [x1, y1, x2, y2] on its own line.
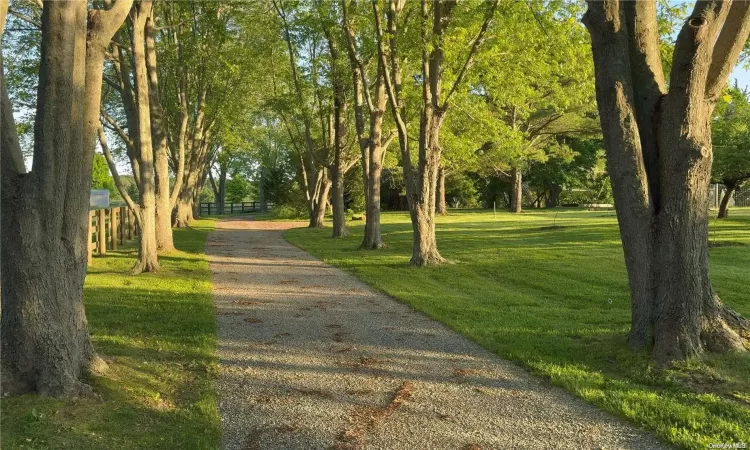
[0, 0, 132, 395]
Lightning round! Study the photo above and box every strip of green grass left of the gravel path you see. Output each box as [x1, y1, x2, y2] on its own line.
[0, 220, 221, 449]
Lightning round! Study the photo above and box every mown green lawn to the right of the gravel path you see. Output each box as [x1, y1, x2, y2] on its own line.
[286, 209, 750, 449]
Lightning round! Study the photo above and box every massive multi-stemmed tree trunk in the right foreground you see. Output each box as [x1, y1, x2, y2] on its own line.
[584, 0, 750, 361]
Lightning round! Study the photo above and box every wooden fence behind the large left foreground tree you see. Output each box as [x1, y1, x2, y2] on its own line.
[88, 206, 138, 264]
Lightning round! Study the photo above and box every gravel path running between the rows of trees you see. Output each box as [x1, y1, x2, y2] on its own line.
[206, 219, 664, 449]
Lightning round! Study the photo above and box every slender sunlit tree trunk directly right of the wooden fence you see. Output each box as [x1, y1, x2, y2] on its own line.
[131, 0, 159, 273]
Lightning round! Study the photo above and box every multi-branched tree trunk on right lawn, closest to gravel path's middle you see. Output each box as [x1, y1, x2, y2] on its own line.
[373, 0, 497, 266]
